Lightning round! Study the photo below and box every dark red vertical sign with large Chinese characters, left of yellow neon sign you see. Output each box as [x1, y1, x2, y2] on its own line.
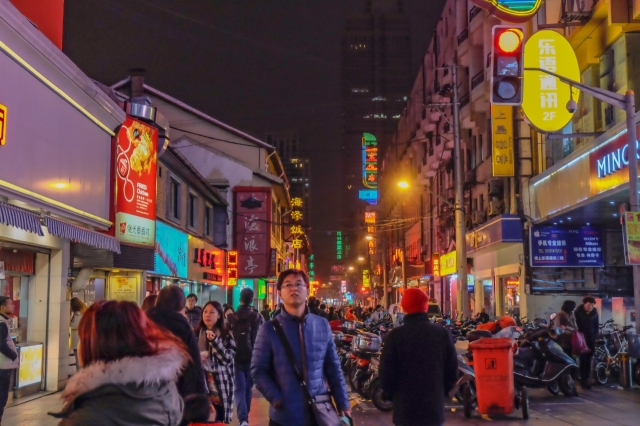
[233, 187, 271, 278]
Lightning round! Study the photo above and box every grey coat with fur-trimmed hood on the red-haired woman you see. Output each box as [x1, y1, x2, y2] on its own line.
[52, 348, 188, 426]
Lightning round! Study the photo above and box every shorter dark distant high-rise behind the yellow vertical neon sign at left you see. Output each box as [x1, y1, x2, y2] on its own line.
[264, 130, 311, 228]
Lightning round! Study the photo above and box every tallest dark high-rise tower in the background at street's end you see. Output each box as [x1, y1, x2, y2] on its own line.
[341, 0, 412, 255]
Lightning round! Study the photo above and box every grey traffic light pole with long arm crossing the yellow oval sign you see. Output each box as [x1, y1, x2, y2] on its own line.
[524, 68, 640, 326]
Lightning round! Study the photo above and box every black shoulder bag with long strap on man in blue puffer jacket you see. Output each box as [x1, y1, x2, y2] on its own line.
[271, 317, 354, 426]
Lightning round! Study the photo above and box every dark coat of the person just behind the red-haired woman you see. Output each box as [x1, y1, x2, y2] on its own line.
[147, 307, 207, 398]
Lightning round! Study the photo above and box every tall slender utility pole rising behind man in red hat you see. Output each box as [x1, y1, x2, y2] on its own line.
[451, 64, 470, 318]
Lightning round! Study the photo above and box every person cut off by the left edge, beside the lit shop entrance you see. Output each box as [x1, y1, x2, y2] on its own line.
[0, 296, 20, 421]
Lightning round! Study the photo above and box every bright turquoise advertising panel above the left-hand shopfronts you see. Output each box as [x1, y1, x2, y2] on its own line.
[151, 221, 189, 278]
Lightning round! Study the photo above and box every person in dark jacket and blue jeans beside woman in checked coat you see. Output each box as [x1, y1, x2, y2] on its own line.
[229, 288, 264, 426]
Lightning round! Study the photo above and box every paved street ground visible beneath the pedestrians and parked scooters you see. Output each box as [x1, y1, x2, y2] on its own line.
[2, 386, 640, 426]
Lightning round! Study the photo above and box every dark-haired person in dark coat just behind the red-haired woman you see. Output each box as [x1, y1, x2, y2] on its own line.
[147, 285, 207, 398]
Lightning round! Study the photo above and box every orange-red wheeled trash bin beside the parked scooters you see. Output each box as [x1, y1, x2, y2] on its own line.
[469, 338, 515, 414]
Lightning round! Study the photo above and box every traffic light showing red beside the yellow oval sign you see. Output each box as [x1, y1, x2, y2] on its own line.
[491, 25, 524, 105]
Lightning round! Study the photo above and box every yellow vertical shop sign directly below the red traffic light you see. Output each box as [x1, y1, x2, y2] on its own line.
[491, 105, 515, 176]
